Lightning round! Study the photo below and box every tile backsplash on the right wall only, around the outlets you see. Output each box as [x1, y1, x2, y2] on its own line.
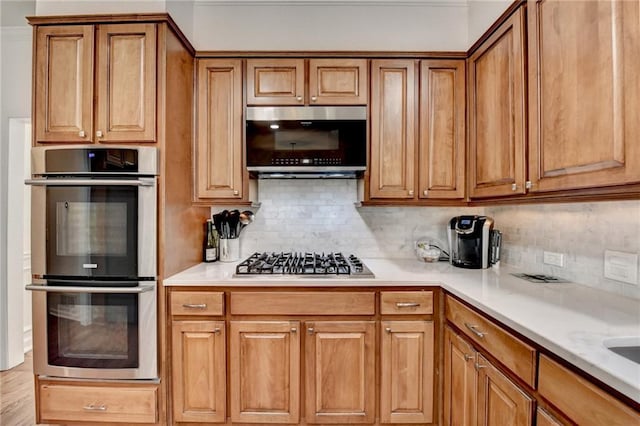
[485, 201, 640, 299]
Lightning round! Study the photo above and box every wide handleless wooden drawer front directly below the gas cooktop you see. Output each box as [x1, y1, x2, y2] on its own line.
[231, 291, 375, 315]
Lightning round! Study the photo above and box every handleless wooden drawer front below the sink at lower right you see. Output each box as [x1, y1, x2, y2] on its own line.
[538, 355, 640, 426]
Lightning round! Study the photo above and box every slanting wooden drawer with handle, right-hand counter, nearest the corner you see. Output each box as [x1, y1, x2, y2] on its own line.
[445, 296, 536, 388]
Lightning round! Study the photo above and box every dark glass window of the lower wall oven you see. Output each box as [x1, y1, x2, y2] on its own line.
[47, 292, 139, 369]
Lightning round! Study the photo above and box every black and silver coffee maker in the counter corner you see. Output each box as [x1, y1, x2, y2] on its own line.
[447, 216, 502, 269]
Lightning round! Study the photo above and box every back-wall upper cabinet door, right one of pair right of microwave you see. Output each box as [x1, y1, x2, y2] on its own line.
[418, 60, 465, 198]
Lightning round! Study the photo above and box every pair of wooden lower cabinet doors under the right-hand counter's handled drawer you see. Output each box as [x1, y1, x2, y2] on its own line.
[444, 328, 534, 426]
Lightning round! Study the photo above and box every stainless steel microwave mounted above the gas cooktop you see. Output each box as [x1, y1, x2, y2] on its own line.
[246, 106, 367, 177]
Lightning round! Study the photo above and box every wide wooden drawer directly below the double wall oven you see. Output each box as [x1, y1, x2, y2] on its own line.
[39, 384, 158, 424]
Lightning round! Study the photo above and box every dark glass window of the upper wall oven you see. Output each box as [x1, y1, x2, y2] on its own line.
[47, 185, 138, 278]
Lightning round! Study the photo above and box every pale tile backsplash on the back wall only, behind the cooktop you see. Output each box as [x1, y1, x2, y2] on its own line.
[212, 179, 482, 259]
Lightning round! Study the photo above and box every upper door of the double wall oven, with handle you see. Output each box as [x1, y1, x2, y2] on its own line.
[28, 177, 156, 280]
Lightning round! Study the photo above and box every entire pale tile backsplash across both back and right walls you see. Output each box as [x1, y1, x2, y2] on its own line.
[212, 179, 640, 299]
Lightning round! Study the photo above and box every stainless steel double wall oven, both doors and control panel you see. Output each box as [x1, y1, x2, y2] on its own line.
[26, 146, 158, 379]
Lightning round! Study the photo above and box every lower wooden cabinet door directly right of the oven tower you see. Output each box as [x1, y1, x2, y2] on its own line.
[171, 321, 227, 423]
